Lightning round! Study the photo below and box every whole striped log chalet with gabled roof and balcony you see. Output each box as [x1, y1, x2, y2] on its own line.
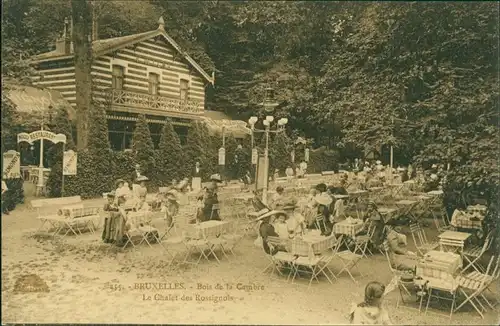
[32, 18, 250, 150]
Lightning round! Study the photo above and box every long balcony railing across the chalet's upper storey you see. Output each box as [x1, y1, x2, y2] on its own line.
[110, 89, 204, 113]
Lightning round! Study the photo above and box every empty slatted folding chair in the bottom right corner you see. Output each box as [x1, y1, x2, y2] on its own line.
[454, 256, 499, 318]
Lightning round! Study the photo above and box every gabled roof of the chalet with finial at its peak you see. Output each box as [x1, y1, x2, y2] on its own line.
[31, 20, 215, 85]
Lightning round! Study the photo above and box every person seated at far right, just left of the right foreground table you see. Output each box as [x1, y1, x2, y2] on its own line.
[386, 226, 418, 272]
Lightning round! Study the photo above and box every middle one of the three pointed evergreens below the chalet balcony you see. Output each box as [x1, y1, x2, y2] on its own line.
[156, 120, 185, 183]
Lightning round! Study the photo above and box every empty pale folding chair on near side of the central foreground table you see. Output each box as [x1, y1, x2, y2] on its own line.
[291, 239, 337, 288]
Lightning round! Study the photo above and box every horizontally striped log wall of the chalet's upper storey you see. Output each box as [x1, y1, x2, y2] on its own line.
[34, 38, 206, 117]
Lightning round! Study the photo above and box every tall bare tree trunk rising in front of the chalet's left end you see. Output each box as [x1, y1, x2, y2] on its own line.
[71, 0, 92, 150]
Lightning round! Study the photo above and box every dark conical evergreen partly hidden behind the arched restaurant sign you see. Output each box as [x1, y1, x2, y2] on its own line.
[47, 106, 76, 197]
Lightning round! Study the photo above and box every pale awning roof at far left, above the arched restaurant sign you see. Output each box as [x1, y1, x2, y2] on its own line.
[6, 84, 76, 120]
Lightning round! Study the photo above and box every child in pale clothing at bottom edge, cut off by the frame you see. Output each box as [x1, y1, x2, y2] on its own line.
[349, 282, 392, 325]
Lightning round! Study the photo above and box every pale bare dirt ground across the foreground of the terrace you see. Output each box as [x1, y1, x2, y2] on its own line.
[2, 188, 499, 325]
